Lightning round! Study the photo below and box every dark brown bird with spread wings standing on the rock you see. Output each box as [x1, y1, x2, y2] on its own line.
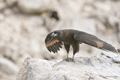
[45, 29, 117, 60]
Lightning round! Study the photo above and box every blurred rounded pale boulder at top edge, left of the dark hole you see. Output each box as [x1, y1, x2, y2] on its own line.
[18, 0, 50, 13]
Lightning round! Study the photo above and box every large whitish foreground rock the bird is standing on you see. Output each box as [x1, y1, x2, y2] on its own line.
[17, 55, 120, 80]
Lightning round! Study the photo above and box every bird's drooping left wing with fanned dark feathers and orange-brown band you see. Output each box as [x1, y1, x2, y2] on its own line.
[45, 39, 62, 53]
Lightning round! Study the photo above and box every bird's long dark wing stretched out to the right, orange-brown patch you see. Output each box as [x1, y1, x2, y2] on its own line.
[74, 32, 117, 52]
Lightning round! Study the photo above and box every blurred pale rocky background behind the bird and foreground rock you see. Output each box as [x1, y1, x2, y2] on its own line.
[0, 0, 120, 80]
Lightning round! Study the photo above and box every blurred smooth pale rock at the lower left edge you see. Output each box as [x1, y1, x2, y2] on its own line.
[0, 58, 18, 75]
